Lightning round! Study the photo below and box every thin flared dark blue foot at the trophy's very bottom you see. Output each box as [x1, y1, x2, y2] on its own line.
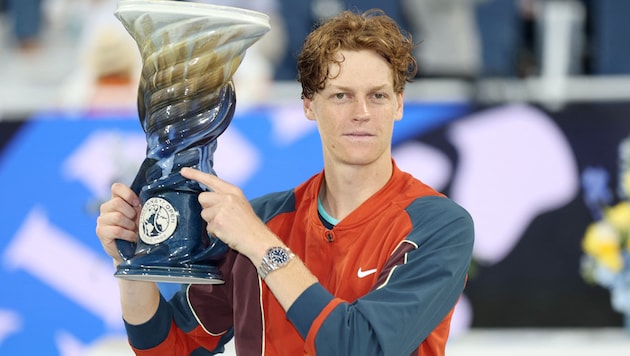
[114, 266, 225, 284]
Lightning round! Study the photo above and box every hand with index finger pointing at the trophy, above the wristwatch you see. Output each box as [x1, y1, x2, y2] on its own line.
[181, 168, 277, 263]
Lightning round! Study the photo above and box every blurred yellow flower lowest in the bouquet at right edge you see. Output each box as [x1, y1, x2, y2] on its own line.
[582, 221, 623, 272]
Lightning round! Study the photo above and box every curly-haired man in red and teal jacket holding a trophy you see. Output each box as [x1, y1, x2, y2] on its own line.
[96, 11, 473, 356]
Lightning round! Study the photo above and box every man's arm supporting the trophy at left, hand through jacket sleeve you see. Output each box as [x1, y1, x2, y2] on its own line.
[96, 183, 232, 355]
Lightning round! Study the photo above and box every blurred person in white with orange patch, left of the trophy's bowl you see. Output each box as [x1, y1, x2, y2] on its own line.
[57, 0, 142, 117]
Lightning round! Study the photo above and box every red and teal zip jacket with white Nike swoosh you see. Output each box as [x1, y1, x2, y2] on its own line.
[125, 164, 474, 356]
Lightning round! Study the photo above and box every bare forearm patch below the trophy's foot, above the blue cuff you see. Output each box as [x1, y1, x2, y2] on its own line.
[118, 279, 160, 325]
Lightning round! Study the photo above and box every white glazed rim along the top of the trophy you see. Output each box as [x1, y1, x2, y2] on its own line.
[115, 0, 269, 28]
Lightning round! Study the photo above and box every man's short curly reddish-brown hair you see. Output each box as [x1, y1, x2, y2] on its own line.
[297, 9, 418, 99]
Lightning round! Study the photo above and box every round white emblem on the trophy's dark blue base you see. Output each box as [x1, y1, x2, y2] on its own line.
[139, 197, 179, 244]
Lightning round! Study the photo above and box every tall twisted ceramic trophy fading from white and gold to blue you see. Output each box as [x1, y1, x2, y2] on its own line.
[115, 0, 269, 284]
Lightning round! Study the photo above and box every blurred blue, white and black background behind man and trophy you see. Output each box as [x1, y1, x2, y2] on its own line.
[0, 0, 630, 356]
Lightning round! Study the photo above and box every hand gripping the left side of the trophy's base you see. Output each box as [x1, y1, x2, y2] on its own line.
[96, 183, 142, 265]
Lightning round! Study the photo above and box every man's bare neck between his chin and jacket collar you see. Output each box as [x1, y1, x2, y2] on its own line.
[319, 159, 393, 220]
